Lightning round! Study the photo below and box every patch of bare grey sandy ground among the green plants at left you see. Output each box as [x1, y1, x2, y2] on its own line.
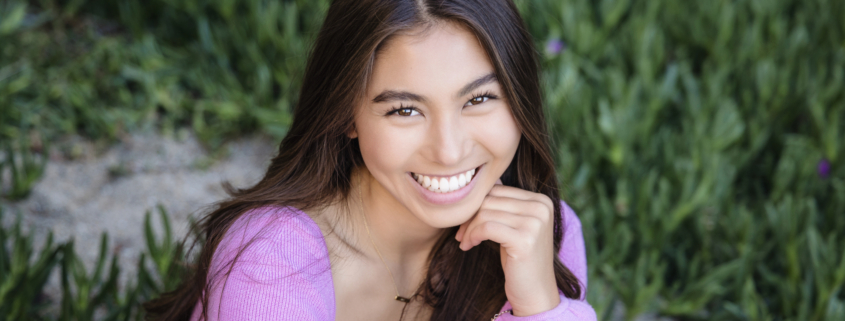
[2, 131, 276, 293]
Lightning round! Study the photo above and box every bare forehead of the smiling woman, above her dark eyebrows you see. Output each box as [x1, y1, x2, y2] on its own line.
[367, 23, 493, 99]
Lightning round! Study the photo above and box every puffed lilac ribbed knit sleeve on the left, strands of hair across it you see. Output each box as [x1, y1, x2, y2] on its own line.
[191, 208, 335, 321]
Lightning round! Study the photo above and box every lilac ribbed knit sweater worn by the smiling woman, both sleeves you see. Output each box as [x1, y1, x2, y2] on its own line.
[191, 202, 596, 321]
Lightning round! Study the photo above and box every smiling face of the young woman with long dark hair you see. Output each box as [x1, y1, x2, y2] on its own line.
[352, 23, 521, 228]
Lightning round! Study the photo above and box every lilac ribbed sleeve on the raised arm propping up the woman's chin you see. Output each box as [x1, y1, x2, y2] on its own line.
[496, 201, 597, 321]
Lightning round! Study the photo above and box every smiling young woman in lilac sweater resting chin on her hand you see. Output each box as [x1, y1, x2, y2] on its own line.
[146, 0, 595, 320]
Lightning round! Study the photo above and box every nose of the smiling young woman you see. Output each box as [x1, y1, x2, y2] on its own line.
[428, 113, 472, 167]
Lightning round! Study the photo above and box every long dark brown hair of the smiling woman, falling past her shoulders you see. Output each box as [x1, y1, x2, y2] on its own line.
[144, 0, 581, 320]
